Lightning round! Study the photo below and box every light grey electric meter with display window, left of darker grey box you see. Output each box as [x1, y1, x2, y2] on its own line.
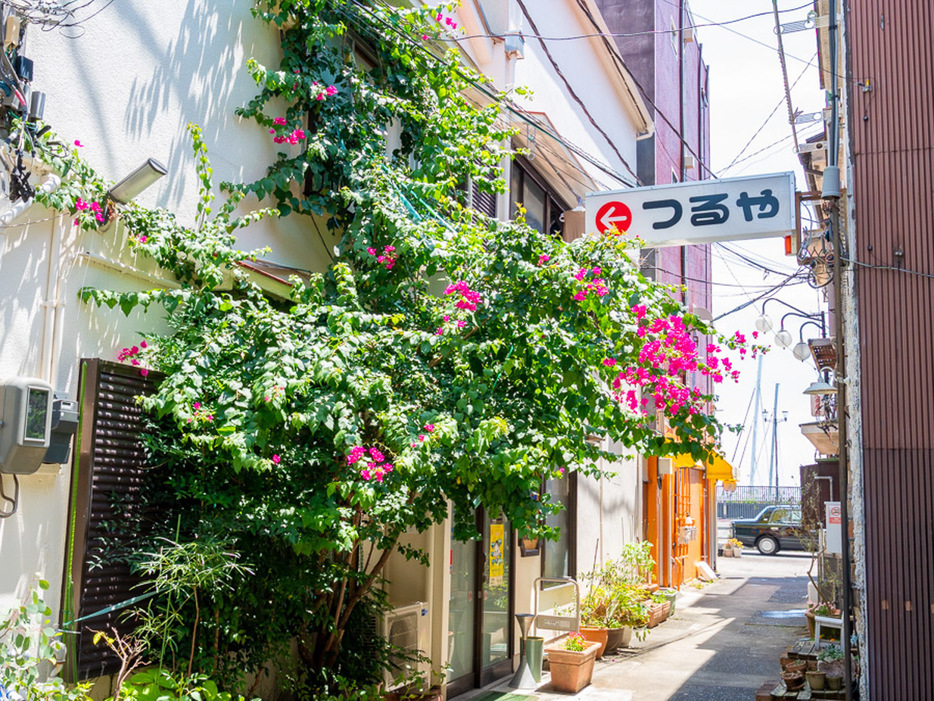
[0, 377, 53, 475]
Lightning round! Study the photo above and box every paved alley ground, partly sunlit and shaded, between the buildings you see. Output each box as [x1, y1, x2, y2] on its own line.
[476, 548, 811, 701]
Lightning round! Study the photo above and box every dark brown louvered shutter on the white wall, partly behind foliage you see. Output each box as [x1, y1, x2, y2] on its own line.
[62, 359, 154, 680]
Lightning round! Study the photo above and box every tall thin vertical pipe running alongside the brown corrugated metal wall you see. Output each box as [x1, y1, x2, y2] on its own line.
[822, 0, 853, 701]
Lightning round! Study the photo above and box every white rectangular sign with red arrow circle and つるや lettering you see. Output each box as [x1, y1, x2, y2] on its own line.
[586, 172, 797, 247]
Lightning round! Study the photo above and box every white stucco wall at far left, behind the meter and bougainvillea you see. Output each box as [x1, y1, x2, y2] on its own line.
[0, 0, 331, 608]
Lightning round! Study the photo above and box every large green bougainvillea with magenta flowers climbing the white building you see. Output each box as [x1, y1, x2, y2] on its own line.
[20, 0, 755, 688]
